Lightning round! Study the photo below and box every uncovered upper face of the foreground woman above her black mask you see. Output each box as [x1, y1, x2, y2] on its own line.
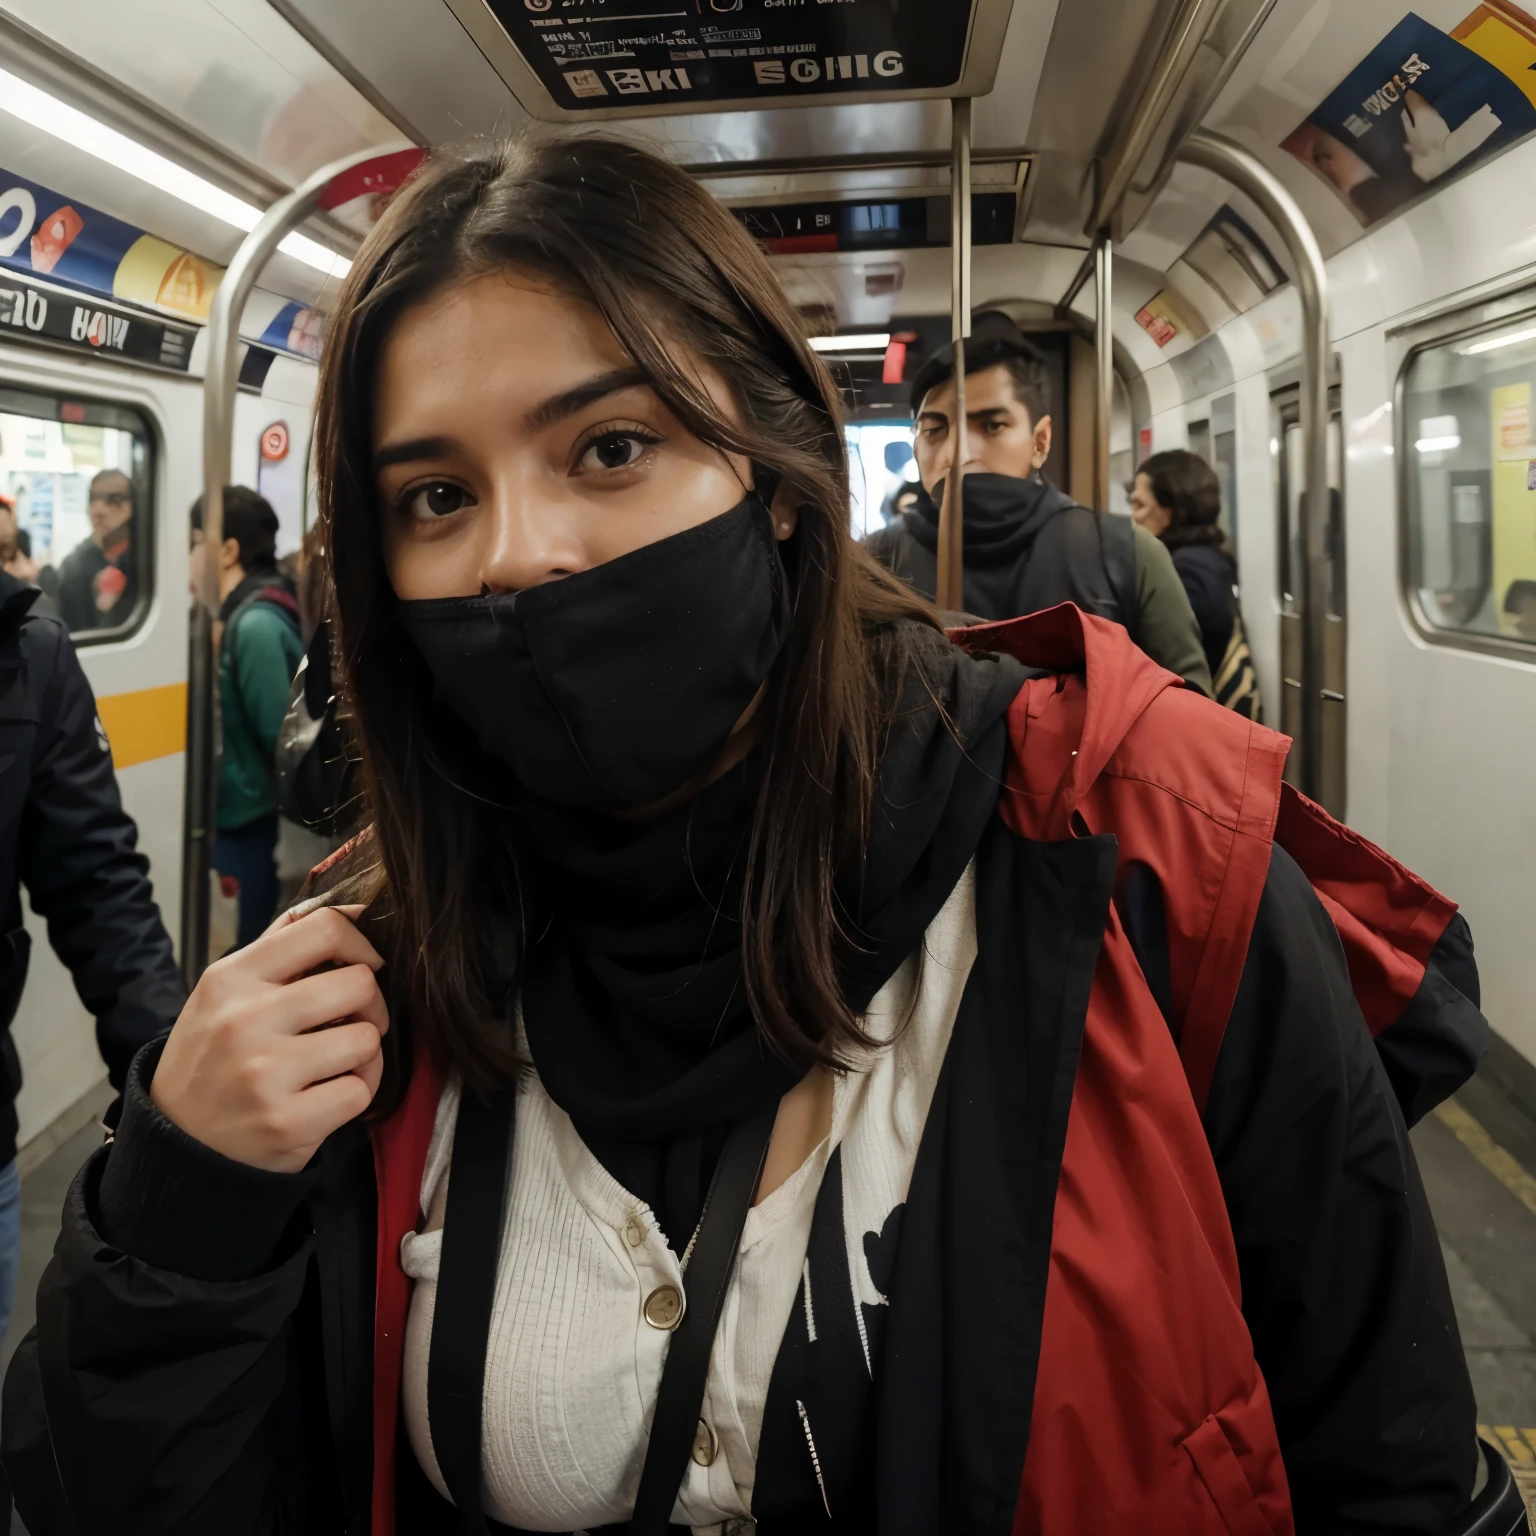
[373, 272, 794, 599]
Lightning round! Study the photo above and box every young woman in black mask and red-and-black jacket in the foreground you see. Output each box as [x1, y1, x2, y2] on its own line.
[5, 138, 1484, 1536]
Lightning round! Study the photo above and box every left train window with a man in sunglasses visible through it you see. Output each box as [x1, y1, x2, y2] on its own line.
[0, 389, 154, 644]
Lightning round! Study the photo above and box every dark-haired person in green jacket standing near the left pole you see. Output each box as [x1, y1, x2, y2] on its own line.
[192, 485, 304, 948]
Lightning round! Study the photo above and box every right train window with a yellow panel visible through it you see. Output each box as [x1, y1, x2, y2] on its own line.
[1399, 319, 1536, 644]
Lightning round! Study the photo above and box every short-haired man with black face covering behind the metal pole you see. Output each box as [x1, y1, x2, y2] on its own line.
[865, 313, 1212, 697]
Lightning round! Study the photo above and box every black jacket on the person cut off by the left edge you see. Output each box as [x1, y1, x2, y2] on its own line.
[0, 571, 186, 1166]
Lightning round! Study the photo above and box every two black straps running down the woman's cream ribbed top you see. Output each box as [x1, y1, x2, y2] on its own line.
[427, 1089, 779, 1536]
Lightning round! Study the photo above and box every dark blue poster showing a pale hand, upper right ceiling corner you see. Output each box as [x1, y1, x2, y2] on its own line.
[1281, 3, 1536, 226]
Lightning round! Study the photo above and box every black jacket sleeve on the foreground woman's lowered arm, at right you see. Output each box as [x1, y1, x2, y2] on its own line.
[1206, 846, 1478, 1536]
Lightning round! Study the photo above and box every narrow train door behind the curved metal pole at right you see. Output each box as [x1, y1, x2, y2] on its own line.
[1273, 387, 1349, 820]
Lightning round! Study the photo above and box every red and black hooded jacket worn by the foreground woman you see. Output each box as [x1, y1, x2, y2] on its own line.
[3, 608, 1485, 1536]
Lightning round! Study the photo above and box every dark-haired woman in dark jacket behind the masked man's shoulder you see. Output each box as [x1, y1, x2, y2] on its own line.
[1130, 449, 1260, 720]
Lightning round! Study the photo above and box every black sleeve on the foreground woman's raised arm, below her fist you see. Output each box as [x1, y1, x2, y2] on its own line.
[0, 1044, 321, 1536]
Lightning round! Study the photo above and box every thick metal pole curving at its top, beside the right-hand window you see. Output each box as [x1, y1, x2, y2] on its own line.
[1178, 129, 1333, 800]
